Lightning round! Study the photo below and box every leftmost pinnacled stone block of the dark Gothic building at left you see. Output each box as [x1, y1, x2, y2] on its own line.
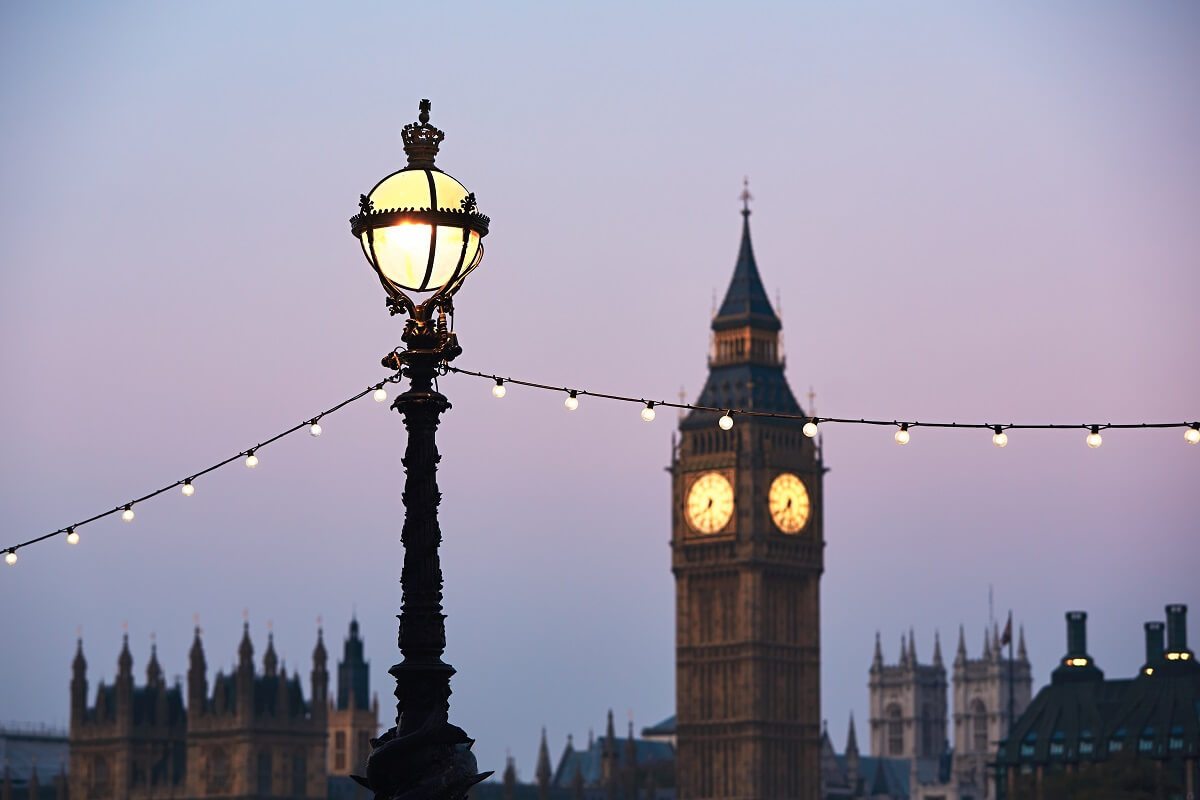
[67, 636, 187, 800]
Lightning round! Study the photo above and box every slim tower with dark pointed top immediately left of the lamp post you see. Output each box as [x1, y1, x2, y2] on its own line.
[326, 619, 379, 775]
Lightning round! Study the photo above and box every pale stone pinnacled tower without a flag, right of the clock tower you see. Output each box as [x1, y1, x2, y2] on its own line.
[870, 630, 947, 758]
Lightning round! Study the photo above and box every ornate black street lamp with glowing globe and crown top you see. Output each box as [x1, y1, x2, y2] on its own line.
[350, 100, 491, 800]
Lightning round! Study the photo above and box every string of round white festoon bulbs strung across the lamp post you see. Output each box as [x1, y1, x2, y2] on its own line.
[0, 365, 1200, 565]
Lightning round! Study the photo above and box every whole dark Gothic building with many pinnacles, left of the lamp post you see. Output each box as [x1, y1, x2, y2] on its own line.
[67, 621, 378, 800]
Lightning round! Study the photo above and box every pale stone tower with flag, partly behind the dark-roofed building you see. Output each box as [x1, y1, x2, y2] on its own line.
[953, 625, 1033, 799]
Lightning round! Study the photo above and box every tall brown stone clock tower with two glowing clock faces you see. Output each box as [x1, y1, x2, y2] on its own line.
[671, 193, 824, 800]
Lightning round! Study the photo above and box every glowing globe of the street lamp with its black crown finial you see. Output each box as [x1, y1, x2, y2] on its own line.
[350, 100, 490, 295]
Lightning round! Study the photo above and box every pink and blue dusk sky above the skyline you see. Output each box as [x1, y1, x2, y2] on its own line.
[0, 1, 1200, 780]
